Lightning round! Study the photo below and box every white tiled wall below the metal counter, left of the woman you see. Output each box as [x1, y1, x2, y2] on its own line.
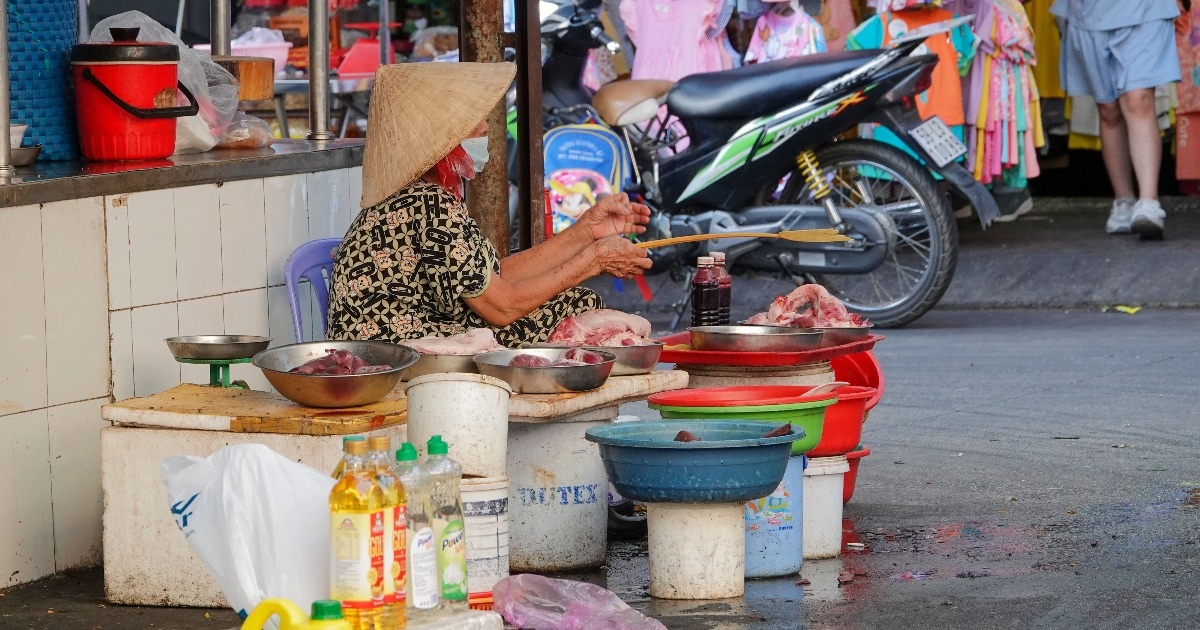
[0, 168, 361, 587]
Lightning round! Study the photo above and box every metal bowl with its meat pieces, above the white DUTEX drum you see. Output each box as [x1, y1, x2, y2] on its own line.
[475, 348, 617, 394]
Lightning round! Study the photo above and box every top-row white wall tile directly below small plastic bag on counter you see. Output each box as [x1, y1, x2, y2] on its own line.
[220, 179, 266, 293]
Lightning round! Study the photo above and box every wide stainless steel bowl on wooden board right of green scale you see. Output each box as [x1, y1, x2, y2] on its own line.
[251, 341, 418, 408]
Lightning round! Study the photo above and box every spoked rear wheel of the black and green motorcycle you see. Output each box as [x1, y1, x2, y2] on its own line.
[779, 139, 959, 328]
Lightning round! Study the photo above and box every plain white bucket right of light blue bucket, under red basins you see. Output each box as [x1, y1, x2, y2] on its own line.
[803, 455, 850, 560]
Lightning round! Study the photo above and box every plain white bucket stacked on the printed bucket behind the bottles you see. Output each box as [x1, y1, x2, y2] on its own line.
[404, 373, 512, 476]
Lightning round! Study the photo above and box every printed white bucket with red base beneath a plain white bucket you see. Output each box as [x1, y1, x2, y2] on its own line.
[458, 476, 509, 601]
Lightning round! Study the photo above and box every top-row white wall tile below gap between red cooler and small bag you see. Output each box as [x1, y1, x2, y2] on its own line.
[174, 184, 222, 300]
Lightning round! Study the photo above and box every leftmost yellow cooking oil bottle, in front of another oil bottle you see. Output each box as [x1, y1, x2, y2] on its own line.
[329, 440, 385, 630]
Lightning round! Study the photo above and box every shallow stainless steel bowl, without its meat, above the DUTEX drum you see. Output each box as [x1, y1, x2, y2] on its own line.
[475, 348, 617, 394]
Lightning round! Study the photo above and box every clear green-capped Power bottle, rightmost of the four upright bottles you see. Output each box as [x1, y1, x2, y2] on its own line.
[425, 436, 468, 613]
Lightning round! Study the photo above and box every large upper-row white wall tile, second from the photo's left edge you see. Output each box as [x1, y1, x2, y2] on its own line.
[42, 197, 109, 406]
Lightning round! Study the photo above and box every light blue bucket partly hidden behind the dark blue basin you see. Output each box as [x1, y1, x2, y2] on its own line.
[745, 455, 808, 577]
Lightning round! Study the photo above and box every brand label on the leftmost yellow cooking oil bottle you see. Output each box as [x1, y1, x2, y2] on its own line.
[329, 511, 384, 608]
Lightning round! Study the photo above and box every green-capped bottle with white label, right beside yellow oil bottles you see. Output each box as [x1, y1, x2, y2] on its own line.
[396, 442, 440, 624]
